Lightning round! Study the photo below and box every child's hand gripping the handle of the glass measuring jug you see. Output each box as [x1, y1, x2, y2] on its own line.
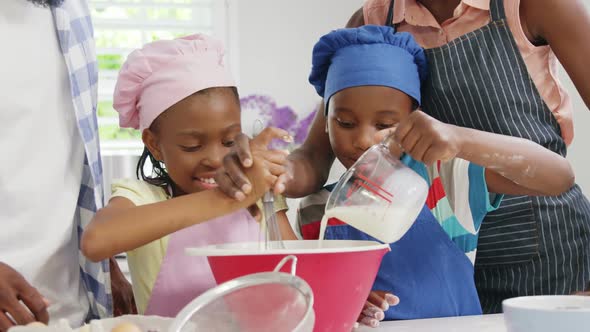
[388, 111, 462, 165]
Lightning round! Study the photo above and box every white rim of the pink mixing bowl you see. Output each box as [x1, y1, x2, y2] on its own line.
[186, 240, 389, 256]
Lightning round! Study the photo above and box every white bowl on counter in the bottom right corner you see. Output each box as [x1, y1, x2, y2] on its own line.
[502, 295, 590, 332]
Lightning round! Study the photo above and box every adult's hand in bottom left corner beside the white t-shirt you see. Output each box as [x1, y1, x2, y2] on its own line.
[0, 263, 49, 332]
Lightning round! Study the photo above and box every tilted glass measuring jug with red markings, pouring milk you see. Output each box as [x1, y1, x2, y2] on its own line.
[320, 140, 428, 243]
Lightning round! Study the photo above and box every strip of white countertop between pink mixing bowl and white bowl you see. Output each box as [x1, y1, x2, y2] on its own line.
[355, 314, 506, 332]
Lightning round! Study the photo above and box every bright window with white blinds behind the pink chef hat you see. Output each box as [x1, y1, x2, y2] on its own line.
[90, 0, 227, 146]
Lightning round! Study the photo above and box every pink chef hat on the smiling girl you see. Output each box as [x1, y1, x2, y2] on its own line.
[113, 34, 235, 130]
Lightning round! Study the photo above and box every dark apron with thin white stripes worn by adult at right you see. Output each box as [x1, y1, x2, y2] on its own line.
[387, 0, 590, 313]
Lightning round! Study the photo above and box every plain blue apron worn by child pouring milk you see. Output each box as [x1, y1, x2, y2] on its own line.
[325, 205, 481, 320]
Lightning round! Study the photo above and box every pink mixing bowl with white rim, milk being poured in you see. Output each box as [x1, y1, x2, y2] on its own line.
[187, 240, 389, 332]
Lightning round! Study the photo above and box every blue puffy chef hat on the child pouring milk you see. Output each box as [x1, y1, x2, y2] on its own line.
[309, 25, 427, 114]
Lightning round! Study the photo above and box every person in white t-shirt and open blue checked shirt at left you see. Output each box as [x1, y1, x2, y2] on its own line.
[0, 0, 132, 331]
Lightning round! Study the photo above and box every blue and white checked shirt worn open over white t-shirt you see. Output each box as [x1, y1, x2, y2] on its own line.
[52, 0, 113, 318]
